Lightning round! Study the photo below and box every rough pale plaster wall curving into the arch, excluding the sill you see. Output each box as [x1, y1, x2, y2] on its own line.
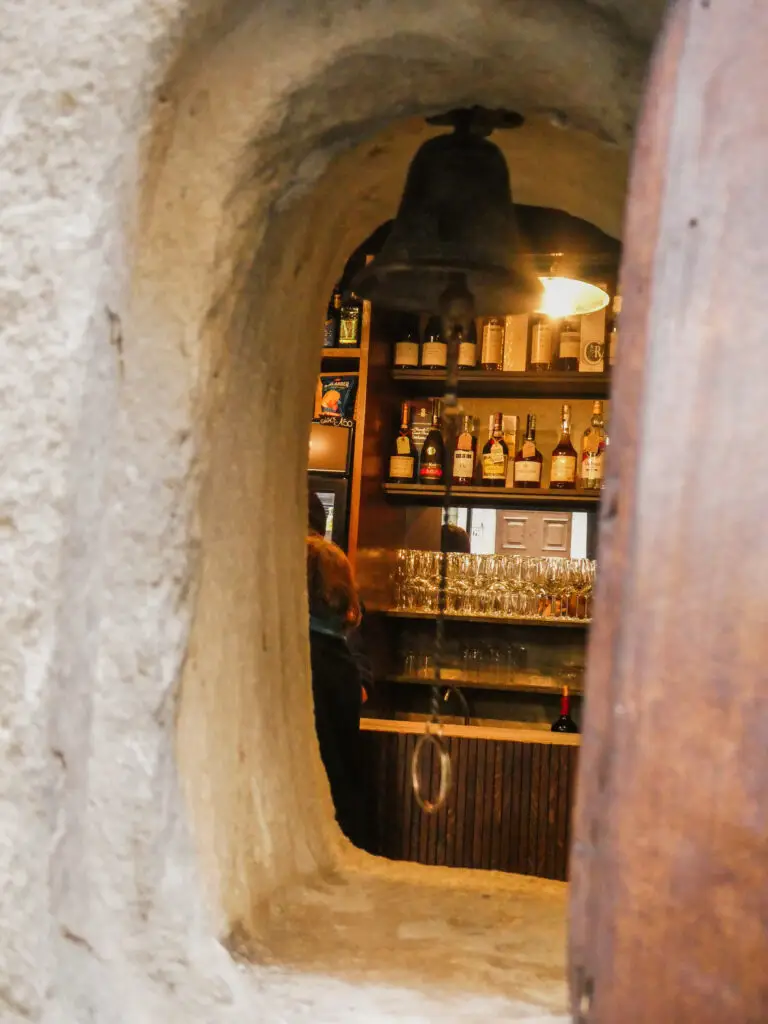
[0, 0, 663, 1022]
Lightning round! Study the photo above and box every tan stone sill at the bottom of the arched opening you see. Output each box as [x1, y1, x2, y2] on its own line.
[238, 862, 569, 1024]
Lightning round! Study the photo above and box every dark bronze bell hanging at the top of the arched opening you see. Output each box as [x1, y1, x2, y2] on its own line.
[352, 111, 542, 316]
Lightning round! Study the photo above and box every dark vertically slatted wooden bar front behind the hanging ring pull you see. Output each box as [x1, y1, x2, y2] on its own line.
[362, 732, 579, 881]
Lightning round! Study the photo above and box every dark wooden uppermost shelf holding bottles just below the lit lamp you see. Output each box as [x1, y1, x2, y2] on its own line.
[392, 370, 610, 398]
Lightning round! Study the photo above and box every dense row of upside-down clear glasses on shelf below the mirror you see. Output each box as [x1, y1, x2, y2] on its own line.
[394, 548, 596, 622]
